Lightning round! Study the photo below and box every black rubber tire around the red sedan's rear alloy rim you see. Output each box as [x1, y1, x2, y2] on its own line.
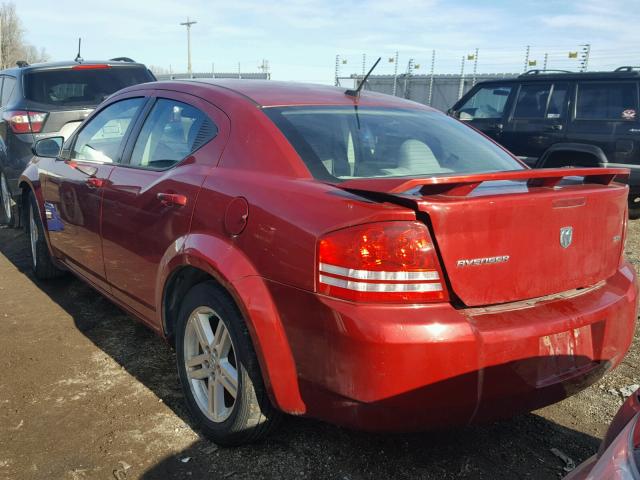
[176, 282, 282, 446]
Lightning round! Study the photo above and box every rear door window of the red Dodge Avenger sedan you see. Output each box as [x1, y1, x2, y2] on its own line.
[130, 98, 218, 169]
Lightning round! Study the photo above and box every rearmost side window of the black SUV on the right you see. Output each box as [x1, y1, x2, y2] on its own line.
[576, 82, 638, 120]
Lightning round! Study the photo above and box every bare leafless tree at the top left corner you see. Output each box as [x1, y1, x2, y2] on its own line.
[0, 2, 49, 69]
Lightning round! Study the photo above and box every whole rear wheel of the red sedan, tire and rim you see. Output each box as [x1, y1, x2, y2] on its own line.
[176, 282, 281, 446]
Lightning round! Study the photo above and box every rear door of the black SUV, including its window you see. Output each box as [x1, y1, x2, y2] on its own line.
[501, 81, 570, 166]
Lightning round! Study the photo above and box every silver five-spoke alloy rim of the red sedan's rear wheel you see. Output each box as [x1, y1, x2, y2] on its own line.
[184, 307, 239, 423]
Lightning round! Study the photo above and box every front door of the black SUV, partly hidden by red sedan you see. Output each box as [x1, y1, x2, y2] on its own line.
[454, 83, 514, 142]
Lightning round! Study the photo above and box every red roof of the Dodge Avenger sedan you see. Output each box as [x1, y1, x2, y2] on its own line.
[137, 78, 433, 110]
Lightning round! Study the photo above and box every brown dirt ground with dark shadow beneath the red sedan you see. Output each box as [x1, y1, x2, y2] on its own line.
[0, 221, 640, 480]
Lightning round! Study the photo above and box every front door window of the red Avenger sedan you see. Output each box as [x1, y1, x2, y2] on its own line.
[71, 98, 145, 163]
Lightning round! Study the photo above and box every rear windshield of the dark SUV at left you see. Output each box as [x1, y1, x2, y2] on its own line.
[25, 67, 153, 106]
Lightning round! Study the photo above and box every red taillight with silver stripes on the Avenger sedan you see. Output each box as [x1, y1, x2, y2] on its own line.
[318, 222, 448, 303]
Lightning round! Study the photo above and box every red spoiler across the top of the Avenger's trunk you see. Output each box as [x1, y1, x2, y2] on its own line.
[334, 167, 630, 196]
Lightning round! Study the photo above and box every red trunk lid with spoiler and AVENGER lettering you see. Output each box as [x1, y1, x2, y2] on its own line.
[339, 168, 628, 306]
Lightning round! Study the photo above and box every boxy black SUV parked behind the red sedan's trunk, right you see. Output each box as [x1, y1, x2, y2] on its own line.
[449, 67, 640, 217]
